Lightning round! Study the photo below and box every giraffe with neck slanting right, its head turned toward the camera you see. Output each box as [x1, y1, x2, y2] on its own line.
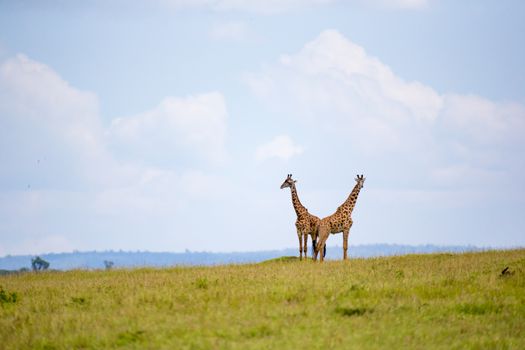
[314, 174, 365, 261]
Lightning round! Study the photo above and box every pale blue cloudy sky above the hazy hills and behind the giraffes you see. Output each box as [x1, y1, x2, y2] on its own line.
[0, 0, 525, 256]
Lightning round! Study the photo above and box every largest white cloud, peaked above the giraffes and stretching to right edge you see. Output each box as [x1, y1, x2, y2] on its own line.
[246, 30, 525, 189]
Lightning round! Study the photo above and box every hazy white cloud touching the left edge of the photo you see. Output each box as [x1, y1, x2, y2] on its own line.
[0, 55, 109, 185]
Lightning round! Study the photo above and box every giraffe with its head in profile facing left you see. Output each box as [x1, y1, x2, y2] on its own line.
[281, 174, 320, 260]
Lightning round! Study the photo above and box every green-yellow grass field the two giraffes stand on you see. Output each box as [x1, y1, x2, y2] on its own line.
[0, 249, 525, 349]
